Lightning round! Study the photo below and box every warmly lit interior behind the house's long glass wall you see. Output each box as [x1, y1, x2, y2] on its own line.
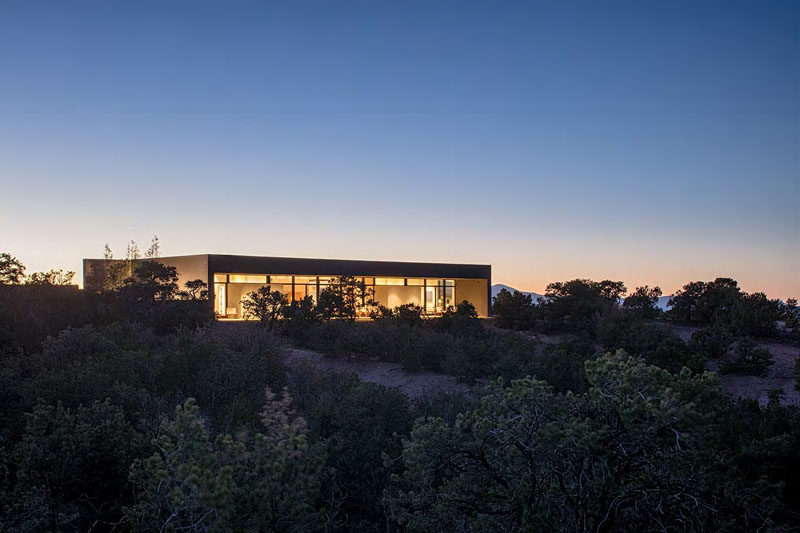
[214, 273, 476, 319]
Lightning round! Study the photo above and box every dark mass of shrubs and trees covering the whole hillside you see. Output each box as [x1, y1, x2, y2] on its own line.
[0, 250, 800, 531]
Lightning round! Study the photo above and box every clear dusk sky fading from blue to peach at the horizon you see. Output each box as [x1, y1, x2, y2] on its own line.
[0, 0, 800, 298]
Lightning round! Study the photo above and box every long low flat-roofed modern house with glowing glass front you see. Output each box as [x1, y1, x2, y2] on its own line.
[83, 254, 492, 319]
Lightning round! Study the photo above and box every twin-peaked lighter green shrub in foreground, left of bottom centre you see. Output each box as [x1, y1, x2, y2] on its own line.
[126, 394, 322, 531]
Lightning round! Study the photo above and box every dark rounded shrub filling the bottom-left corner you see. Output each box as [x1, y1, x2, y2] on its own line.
[0, 401, 146, 531]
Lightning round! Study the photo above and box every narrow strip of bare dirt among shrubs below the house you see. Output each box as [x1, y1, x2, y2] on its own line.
[285, 348, 473, 400]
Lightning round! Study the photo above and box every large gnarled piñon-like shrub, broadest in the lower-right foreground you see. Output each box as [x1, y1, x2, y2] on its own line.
[388, 354, 785, 531]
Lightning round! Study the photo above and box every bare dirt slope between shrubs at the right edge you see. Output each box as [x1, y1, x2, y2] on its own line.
[665, 325, 800, 407]
